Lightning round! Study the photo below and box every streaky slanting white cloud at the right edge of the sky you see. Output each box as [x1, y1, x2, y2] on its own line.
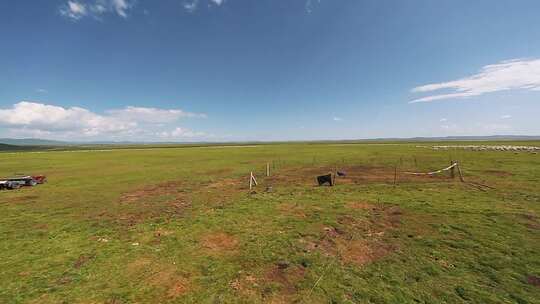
[410, 59, 540, 103]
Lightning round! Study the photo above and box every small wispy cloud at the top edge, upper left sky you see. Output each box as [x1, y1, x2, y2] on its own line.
[59, 0, 135, 21]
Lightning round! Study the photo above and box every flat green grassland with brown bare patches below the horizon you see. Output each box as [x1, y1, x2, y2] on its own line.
[0, 142, 540, 303]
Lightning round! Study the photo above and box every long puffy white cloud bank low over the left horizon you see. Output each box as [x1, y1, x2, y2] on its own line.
[0, 101, 206, 140]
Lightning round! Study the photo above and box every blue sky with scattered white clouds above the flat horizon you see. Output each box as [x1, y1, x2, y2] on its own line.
[0, 0, 540, 141]
